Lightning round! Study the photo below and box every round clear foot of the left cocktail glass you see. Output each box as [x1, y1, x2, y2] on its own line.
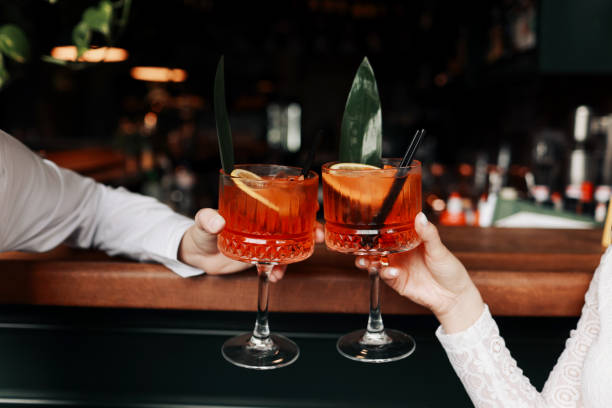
[221, 333, 300, 370]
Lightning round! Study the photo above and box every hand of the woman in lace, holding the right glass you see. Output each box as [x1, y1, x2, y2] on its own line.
[356, 213, 484, 333]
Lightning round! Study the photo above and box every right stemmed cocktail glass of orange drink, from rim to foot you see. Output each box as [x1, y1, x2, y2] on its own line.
[322, 159, 421, 363]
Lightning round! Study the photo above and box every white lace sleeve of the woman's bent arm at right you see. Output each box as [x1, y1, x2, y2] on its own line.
[436, 253, 603, 408]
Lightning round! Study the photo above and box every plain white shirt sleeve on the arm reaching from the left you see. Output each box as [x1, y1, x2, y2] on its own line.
[0, 131, 203, 277]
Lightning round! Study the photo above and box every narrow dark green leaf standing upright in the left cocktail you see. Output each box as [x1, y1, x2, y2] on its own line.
[214, 56, 234, 174]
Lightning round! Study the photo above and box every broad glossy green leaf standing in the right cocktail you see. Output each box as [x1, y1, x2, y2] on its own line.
[339, 57, 382, 166]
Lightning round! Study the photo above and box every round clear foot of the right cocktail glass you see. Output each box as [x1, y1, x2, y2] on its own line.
[336, 329, 416, 363]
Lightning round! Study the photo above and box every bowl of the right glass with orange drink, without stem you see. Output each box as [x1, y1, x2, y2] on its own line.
[322, 159, 421, 255]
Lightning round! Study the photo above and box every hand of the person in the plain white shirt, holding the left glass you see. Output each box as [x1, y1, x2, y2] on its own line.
[178, 208, 324, 282]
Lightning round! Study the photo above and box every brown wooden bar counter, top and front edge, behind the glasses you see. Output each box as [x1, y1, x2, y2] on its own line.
[0, 227, 603, 316]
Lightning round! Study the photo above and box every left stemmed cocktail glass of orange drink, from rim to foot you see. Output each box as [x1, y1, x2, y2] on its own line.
[218, 164, 319, 370]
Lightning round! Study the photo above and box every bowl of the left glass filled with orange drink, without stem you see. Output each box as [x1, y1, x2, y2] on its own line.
[218, 164, 319, 264]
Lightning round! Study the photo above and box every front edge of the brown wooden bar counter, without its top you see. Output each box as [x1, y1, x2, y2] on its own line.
[0, 255, 598, 316]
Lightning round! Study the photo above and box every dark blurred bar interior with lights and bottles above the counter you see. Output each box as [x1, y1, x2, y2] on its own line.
[0, 0, 612, 228]
